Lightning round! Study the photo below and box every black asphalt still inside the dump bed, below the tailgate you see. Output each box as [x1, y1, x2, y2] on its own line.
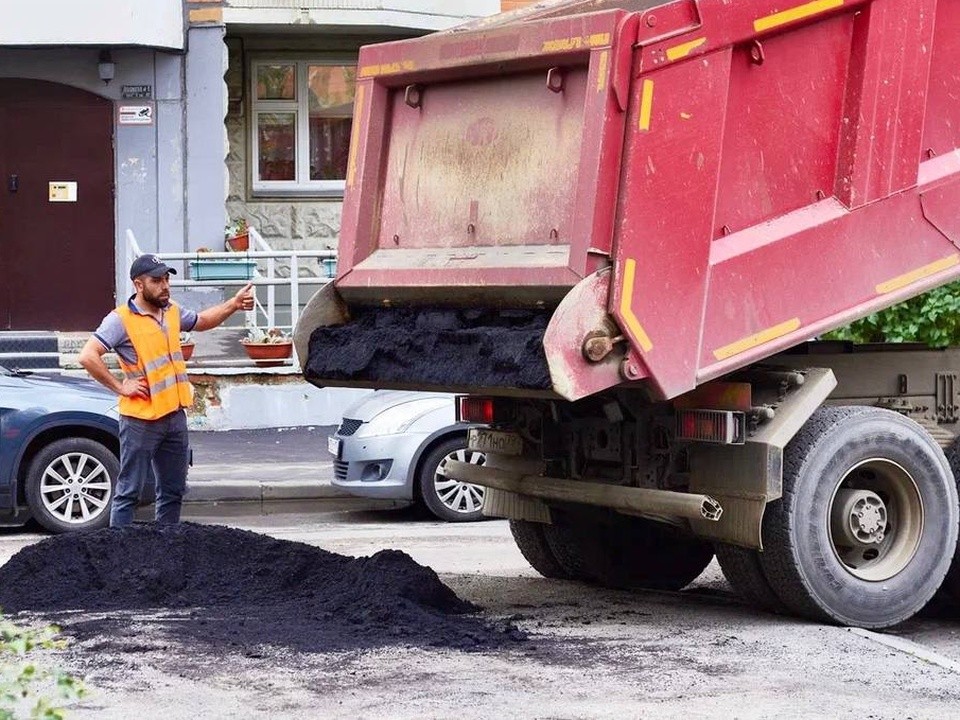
[304, 307, 551, 390]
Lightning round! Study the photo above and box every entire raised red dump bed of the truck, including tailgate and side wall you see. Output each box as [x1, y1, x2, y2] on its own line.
[300, 0, 960, 399]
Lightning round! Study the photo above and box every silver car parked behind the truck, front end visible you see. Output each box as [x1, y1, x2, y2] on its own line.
[328, 390, 484, 522]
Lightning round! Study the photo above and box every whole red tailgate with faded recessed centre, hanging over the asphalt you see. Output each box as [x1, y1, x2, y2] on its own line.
[337, 11, 636, 304]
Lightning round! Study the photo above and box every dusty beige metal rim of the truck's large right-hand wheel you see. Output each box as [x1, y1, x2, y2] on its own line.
[827, 458, 924, 582]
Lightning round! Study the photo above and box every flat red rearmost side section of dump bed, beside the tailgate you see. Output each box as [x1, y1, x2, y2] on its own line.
[610, 50, 730, 396]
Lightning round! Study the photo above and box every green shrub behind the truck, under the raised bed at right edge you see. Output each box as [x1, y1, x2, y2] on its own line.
[823, 281, 960, 347]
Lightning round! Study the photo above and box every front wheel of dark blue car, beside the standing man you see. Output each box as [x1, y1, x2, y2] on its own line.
[24, 437, 120, 533]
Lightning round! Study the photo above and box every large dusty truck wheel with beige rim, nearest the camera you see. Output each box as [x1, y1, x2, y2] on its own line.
[760, 407, 958, 629]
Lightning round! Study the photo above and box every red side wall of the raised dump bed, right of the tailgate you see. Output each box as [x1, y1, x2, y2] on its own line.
[611, 0, 960, 397]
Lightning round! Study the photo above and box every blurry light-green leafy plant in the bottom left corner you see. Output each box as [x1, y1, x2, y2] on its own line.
[0, 616, 85, 720]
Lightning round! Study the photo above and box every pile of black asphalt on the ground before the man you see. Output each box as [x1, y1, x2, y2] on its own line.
[0, 523, 525, 652]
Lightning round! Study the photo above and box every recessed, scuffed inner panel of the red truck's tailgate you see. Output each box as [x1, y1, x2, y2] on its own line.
[377, 66, 587, 256]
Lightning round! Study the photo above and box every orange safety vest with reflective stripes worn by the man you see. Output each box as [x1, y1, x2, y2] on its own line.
[117, 303, 193, 420]
